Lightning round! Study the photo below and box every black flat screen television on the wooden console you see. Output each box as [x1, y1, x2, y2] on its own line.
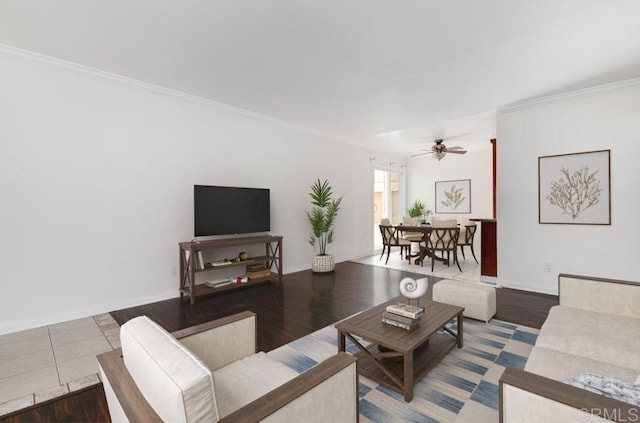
[193, 185, 271, 237]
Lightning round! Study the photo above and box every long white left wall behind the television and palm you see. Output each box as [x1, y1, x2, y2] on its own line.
[0, 48, 398, 333]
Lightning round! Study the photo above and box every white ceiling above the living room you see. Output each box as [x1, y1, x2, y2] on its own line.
[0, 0, 640, 156]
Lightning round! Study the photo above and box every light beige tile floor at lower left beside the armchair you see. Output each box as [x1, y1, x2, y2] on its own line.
[0, 313, 120, 416]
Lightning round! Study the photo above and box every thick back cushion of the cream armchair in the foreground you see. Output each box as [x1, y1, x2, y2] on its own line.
[120, 316, 218, 422]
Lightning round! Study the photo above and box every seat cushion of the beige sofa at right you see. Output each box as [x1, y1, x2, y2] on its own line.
[536, 306, 640, 373]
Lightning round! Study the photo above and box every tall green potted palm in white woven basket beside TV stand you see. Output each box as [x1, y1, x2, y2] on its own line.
[306, 179, 342, 273]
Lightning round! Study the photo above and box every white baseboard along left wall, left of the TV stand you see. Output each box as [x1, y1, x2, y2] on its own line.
[0, 290, 179, 335]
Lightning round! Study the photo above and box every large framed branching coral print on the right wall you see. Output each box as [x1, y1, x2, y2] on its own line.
[538, 150, 611, 225]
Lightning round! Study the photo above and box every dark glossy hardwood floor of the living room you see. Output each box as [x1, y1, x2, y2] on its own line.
[0, 262, 557, 423]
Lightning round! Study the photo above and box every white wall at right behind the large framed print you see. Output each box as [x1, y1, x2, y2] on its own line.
[497, 81, 640, 294]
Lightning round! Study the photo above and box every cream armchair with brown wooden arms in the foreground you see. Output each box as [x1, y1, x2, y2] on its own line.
[98, 311, 358, 422]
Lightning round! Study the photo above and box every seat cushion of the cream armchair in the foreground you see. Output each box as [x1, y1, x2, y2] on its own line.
[213, 351, 298, 418]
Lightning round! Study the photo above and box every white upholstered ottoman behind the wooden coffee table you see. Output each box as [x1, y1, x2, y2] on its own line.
[433, 279, 496, 322]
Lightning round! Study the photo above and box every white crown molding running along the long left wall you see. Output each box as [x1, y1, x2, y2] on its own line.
[0, 43, 354, 145]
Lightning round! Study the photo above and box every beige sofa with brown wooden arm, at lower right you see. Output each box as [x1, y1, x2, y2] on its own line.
[499, 274, 640, 423]
